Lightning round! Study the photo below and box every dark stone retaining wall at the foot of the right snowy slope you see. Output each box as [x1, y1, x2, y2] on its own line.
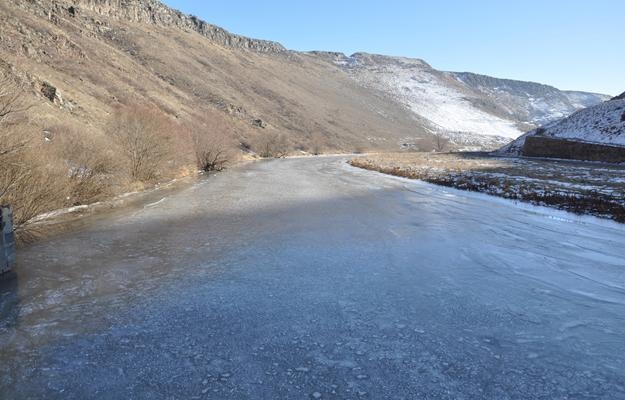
[522, 136, 625, 163]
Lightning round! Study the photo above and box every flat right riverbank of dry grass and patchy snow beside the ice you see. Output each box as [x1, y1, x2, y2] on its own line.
[349, 153, 625, 222]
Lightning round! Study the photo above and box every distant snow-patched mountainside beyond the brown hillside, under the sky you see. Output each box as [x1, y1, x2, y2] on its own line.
[314, 52, 609, 149]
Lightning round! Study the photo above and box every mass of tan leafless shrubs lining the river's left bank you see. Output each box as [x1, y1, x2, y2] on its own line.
[0, 69, 232, 234]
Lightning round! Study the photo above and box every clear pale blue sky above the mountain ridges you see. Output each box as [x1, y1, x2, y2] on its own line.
[165, 0, 625, 95]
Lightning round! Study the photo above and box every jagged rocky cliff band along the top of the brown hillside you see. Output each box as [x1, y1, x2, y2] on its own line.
[14, 0, 286, 53]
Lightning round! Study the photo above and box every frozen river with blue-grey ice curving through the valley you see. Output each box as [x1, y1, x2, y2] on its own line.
[0, 157, 625, 400]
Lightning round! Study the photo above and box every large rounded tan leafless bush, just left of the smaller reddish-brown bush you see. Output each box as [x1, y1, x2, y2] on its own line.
[108, 106, 173, 182]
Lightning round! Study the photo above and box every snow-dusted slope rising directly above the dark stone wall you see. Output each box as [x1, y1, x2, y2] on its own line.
[499, 93, 625, 155]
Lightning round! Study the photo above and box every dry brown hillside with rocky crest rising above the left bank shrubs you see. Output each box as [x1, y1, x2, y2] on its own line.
[0, 0, 426, 151]
